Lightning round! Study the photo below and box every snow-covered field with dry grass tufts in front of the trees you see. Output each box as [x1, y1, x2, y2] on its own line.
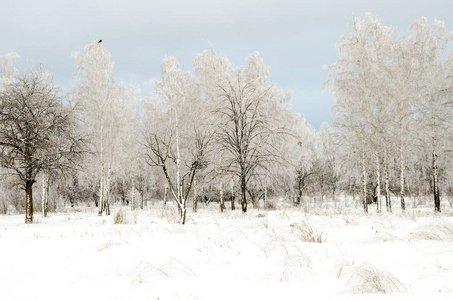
[0, 205, 453, 300]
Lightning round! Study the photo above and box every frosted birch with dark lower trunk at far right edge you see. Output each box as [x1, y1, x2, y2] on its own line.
[411, 17, 453, 212]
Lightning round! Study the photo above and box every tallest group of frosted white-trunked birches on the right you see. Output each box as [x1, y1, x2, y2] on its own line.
[326, 15, 453, 212]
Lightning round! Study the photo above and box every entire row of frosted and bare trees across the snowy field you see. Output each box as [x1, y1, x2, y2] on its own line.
[0, 16, 453, 224]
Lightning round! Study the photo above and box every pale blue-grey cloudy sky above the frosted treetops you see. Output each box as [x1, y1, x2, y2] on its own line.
[0, 0, 453, 128]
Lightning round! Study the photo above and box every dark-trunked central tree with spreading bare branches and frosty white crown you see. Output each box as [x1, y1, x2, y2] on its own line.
[194, 52, 288, 212]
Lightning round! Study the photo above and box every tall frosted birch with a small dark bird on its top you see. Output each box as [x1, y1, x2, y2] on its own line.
[74, 42, 134, 215]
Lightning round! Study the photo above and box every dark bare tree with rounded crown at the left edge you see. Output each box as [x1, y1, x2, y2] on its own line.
[0, 71, 82, 223]
